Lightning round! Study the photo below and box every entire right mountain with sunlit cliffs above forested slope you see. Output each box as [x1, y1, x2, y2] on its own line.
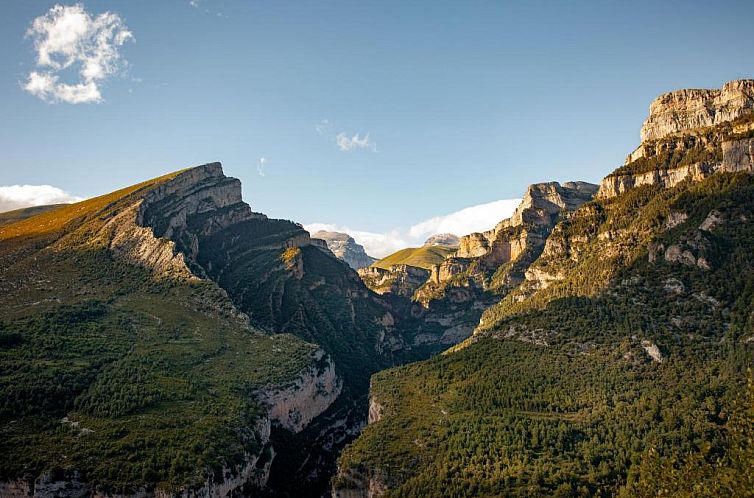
[333, 80, 754, 497]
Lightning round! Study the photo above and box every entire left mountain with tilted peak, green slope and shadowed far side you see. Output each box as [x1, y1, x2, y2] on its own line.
[0, 163, 420, 496]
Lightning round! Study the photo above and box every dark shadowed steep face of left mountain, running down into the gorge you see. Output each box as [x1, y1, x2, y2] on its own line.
[129, 163, 418, 496]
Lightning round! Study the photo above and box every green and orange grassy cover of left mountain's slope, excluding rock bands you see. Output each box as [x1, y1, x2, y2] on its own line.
[0, 170, 315, 491]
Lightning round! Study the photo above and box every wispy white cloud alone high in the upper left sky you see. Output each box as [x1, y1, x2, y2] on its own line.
[23, 3, 133, 104]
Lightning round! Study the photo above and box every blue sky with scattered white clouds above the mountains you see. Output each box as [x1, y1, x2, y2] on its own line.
[0, 0, 754, 256]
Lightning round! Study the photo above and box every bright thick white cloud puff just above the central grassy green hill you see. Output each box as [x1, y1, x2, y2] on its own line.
[409, 199, 521, 239]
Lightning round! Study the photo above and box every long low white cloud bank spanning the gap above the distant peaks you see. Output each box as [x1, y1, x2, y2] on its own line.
[304, 199, 521, 258]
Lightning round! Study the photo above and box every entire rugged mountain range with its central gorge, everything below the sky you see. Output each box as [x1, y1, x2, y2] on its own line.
[0, 80, 754, 498]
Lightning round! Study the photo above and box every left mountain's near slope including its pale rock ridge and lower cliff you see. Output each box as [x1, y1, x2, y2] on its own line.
[0, 168, 342, 497]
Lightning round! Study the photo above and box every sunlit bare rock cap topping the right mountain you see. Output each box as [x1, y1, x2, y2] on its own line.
[641, 80, 754, 142]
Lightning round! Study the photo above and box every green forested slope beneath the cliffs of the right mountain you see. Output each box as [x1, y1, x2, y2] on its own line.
[340, 175, 754, 497]
